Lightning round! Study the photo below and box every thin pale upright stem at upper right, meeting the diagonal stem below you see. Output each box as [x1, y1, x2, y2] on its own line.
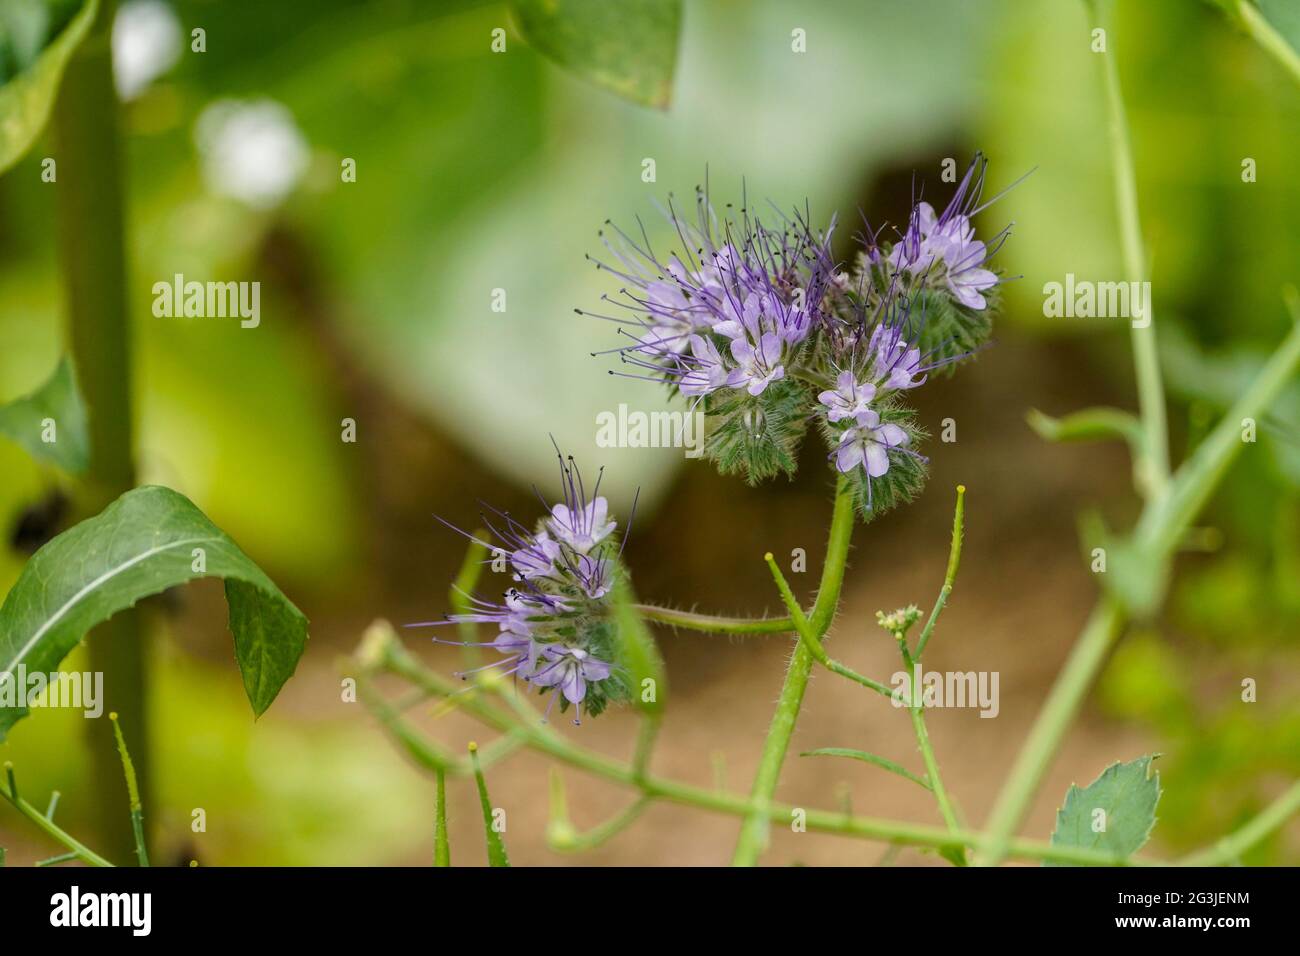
[1101, 0, 1169, 499]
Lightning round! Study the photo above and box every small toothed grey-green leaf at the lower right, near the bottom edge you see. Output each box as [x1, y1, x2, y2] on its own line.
[1043, 756, 1160, 866]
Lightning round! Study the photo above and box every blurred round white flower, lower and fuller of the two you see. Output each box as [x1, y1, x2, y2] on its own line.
[194, 99, 308, 209]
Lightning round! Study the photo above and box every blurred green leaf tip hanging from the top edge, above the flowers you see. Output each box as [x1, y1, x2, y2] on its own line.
[511, 0, 681, 109]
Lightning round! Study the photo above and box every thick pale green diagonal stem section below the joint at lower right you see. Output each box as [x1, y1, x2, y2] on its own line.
[975, 597, 1125, 866]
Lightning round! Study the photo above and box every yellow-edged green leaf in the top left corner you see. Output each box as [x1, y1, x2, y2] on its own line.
[0, 0, 99, 173]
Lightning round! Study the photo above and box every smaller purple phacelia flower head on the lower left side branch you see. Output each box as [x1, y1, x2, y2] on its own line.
[411, 457, 636, 723]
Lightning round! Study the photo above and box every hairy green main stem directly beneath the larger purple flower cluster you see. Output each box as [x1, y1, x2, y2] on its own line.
[732, 475, 853, 866]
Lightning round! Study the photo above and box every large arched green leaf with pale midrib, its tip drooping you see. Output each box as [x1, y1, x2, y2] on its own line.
[0, 486, 307, 740]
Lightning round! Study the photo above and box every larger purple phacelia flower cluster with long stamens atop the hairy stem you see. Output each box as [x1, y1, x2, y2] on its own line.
[590, 156, 1008, 516]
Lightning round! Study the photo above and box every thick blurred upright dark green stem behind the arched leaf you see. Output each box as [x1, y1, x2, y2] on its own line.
[53, 0, 150, 857]
